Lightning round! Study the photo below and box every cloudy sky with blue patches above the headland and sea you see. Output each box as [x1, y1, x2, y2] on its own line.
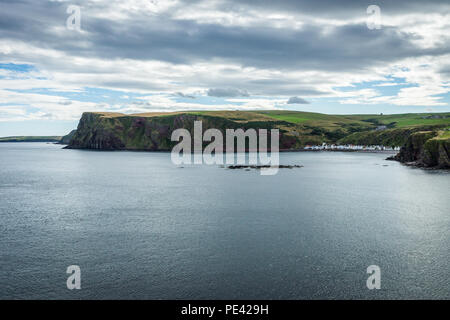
[0, 0, 450, 136]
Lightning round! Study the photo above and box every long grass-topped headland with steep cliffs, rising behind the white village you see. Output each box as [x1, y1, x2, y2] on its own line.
[68, 110, 450, 151]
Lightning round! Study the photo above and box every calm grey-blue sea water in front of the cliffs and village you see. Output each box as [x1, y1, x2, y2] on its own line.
[0, 143, 450, 299]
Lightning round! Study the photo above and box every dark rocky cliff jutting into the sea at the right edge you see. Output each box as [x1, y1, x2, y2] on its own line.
[392, 131, 450, 168]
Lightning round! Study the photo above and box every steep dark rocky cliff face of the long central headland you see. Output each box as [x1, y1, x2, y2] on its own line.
[66, 112, 302, 151]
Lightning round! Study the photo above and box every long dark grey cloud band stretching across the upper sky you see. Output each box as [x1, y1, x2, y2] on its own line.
[0, 1, 450, 71]
